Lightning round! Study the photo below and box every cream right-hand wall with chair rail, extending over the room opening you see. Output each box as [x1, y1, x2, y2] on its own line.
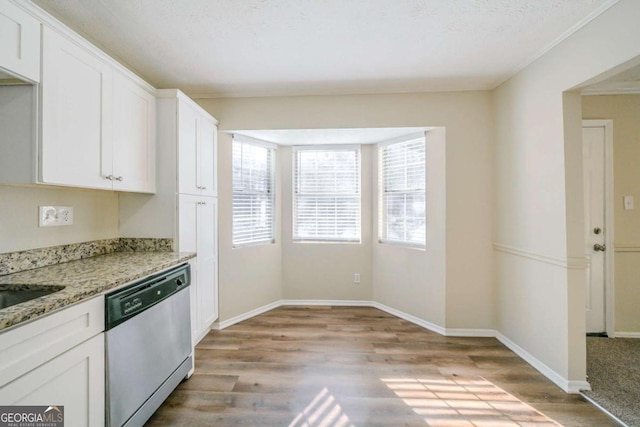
[494, 0, 640, 388]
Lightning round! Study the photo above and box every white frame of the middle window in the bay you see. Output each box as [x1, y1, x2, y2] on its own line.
[291, 144, 362, 244]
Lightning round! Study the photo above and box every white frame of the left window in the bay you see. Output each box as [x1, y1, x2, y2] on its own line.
[231, 134, 278, 249]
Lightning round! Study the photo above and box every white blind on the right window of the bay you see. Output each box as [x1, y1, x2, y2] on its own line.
[378, 137, 426, 247]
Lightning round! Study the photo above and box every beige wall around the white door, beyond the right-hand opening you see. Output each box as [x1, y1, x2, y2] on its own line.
[582, 95, 640, 334]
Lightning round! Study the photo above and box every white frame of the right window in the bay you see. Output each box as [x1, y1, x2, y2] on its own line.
[376, 132, 427, 250]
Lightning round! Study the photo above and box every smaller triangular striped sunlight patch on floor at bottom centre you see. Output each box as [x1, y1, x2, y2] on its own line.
[289, 387, 353, 427]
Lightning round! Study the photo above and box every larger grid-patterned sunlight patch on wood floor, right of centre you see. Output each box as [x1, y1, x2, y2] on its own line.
[382, 377, 560, 427]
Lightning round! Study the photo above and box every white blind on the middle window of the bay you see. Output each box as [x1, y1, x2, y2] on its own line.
[293, 146, 360, 242]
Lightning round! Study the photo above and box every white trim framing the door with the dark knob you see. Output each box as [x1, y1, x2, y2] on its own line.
[582, 120, 616, 338]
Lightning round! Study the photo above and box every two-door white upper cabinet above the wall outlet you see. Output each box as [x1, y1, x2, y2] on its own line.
[40, 26, 155, 193]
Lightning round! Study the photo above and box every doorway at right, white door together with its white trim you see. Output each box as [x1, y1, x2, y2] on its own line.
[582, 120, 615, 336]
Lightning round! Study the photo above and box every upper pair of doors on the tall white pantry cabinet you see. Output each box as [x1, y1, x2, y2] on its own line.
[178, 100, 217, 196]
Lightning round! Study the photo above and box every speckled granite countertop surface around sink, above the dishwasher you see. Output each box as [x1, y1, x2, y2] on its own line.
[0, 251, 195, 333]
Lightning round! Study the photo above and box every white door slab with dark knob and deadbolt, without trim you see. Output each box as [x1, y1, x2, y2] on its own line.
[582, 127, 607, 333]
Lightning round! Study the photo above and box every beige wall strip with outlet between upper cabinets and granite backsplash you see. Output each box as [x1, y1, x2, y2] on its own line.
[0, 185, 119, 253]
